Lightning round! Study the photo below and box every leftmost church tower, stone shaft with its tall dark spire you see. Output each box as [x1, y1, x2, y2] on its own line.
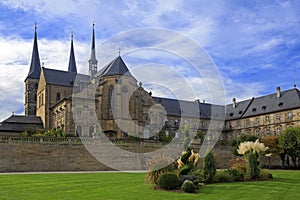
[24, 24, 41, 115]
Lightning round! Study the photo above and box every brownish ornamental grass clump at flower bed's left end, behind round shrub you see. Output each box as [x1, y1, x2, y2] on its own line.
[145, 156, 175, 184]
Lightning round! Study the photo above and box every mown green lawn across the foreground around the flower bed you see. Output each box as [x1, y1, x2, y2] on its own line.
[0, 171, 300, 200]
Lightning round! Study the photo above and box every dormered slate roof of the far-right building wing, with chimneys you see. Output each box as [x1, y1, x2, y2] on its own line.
[226, 88, 300, 120]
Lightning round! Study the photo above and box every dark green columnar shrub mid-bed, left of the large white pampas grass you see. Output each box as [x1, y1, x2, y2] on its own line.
[203, 151, 217, 182]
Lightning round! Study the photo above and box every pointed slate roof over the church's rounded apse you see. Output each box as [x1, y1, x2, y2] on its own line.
[98, 56, 133, 77]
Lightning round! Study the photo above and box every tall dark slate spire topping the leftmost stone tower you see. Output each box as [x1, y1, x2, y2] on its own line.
[26, 23, 41, 79]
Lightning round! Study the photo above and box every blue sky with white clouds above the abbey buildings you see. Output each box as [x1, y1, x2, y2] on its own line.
[0, 0, 300, 121]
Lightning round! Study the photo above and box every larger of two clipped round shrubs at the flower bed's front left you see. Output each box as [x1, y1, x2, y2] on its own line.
[157, 172, 179, 190]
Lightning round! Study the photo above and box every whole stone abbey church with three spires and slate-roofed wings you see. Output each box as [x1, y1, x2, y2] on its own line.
[0, 25, 300, 139]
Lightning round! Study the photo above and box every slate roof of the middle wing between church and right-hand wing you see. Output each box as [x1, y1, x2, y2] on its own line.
[153, 97, 225, 120]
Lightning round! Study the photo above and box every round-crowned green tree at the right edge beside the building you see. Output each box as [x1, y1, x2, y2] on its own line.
[278, 127, 300, 167]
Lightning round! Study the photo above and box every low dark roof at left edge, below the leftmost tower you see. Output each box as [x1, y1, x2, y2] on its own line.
[0, 115, 43, 132]
